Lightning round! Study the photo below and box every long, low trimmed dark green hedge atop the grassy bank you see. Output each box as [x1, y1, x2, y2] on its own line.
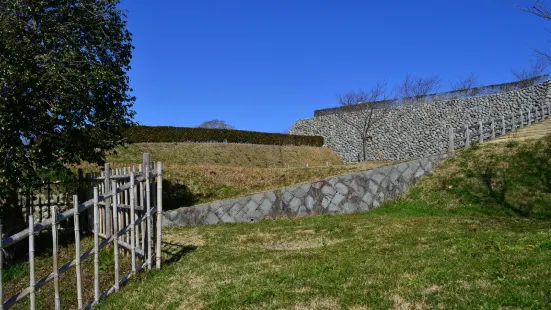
[124, 126, 323, 146]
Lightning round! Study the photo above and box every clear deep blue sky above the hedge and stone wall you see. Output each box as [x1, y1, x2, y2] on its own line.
[122, 0, 551, 132]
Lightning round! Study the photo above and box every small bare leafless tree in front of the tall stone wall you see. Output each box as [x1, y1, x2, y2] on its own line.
[336, 82, 393, 161]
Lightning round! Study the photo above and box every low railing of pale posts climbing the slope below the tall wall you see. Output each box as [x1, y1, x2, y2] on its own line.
[448, 103, 551, 152]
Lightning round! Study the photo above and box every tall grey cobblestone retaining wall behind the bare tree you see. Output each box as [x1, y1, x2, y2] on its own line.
[290, 81, 551, 162]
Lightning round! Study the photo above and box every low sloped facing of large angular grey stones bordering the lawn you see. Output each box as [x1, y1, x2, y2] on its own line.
[163, 154, 447, 227]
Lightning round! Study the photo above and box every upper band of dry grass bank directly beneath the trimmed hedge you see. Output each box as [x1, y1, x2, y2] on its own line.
[108, 143, 343, 168]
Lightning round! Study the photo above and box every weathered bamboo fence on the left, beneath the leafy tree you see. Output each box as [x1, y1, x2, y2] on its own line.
[0, 154, 163, 309]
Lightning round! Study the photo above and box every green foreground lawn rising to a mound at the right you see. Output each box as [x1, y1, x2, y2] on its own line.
[90, 139, 551, 309]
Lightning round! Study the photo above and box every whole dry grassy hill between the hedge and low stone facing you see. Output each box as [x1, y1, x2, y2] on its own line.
[97, 143, 391, 210]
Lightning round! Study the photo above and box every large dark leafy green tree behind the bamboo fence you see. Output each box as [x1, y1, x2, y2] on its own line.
[0, 0, 135, 240]
